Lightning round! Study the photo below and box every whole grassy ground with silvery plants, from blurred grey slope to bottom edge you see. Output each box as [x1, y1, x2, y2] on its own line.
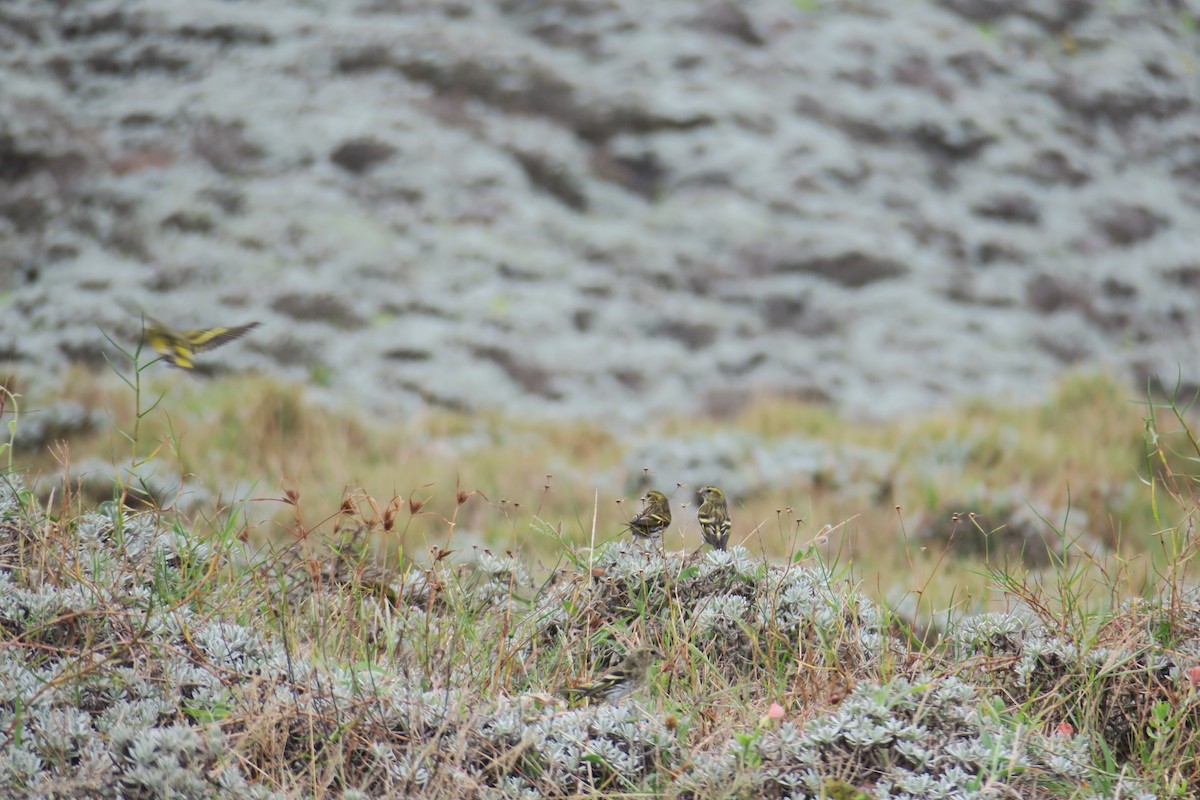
[7, 373, 1200, 798]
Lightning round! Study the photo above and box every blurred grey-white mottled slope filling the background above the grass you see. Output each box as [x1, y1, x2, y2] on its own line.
[0, 0, 1200, 419]
